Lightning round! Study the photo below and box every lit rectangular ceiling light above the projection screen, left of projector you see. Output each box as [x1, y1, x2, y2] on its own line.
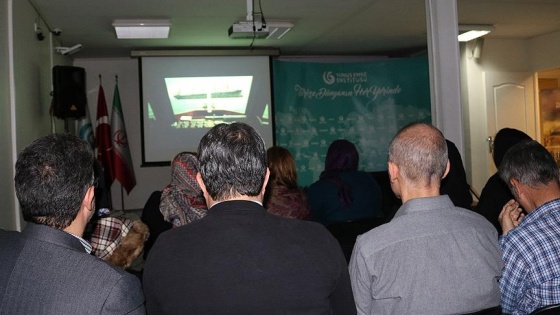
[113, 20, 171, 39]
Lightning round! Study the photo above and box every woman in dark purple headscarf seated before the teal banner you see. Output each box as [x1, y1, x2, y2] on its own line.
[308, 140, 383, 226]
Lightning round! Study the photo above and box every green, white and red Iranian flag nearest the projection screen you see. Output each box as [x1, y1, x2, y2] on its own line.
[111, 85, 136, 194]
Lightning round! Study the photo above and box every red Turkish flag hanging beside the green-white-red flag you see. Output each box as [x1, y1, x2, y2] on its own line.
[95, 84, 115, 187]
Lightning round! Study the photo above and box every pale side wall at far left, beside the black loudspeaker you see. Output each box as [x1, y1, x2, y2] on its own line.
[0, 0, 69, 230]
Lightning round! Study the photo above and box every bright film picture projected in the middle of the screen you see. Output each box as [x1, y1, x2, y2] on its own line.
[165, 76, 253, 128]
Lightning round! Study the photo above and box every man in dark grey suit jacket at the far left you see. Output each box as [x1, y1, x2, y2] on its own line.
[0, 134, 145, 314]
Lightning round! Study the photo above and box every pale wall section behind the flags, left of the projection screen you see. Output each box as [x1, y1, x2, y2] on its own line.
[74, 58, 173, 210]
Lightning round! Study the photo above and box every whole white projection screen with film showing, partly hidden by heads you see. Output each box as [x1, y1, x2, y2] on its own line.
[140, 56, 273, 166]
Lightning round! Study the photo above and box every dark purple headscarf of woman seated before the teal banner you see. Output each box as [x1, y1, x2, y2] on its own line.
[319, 139, 360, 207]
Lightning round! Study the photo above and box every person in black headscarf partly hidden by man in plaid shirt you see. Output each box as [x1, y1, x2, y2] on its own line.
[476, 128, 531, 235]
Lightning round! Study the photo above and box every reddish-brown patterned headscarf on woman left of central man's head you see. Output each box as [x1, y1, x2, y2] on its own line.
[159, 152, 208, 227]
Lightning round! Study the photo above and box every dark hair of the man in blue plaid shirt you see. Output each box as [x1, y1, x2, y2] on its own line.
[499, 140, 560, 191]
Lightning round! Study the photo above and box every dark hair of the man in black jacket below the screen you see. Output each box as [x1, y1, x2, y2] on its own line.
[198, 123, 266, 201]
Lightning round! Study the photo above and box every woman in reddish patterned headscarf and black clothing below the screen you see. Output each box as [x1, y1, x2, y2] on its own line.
[141, 152, 208, 258]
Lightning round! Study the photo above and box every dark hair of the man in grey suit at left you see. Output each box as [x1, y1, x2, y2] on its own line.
[14, 134, 93, 229]
